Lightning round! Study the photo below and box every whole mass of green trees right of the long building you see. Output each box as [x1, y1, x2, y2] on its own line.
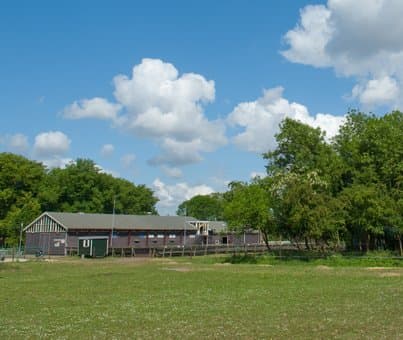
[177, 111, 403, 255]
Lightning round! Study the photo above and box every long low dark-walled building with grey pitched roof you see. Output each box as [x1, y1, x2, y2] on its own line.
[24, 212, 260, 256]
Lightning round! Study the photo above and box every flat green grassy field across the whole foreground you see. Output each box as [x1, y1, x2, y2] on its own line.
[0, 258, 403, 339]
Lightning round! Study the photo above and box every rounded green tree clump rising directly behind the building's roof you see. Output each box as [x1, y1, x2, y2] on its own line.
[41, 159, 157, 214]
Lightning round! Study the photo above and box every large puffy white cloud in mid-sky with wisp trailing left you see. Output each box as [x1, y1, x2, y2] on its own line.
[64, 59, 227, 167]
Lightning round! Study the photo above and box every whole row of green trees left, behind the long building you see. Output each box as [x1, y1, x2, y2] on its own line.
[0, 153, 158, 246]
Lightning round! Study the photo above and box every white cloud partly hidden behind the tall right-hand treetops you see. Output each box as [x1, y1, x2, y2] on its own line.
[228, 87, 344, 152]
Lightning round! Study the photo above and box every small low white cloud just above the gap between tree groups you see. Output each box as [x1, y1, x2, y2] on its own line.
[152, 178, 214, 215]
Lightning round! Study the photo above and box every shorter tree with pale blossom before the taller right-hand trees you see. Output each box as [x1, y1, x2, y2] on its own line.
[271, 171, 344, 249]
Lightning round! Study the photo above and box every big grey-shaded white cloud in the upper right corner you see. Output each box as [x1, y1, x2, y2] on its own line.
[282, 0, 403, 107]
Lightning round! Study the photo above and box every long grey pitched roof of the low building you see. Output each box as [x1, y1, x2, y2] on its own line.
[46, 212, 196, 230]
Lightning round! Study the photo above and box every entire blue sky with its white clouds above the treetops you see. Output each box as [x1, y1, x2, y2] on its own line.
[0, 0, 403, 214]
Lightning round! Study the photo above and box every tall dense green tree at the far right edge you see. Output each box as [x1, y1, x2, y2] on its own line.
[334, 111, 403, 252]
